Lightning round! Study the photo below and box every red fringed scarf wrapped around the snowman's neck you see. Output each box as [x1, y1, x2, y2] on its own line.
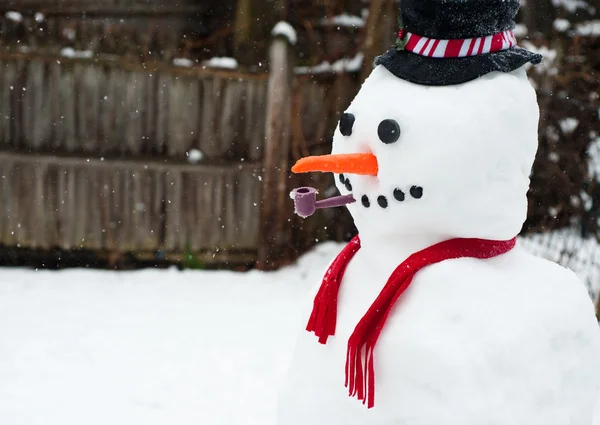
[306, 236, 516, 408]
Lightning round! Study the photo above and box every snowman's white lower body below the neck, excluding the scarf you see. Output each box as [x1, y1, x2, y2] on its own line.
[279, 243, 600, 425]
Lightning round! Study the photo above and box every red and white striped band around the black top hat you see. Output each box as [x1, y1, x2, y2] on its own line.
[398, 30, 517, 58]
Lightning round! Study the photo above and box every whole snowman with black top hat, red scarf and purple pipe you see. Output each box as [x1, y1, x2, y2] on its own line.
[278, 0, 600, 425]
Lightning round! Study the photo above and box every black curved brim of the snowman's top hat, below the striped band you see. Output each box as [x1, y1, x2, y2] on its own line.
[375, 47, 542, 86]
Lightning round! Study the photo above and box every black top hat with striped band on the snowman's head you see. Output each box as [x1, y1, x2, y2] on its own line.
[375, 0, 542, 86]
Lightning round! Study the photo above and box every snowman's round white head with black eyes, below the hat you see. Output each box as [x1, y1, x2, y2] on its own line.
[296, 66, 539, 239]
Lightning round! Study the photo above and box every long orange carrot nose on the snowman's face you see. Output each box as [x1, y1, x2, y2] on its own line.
[292, 153, 379, 176]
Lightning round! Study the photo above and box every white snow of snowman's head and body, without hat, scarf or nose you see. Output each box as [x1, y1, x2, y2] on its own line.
[278, 66, 600, 425]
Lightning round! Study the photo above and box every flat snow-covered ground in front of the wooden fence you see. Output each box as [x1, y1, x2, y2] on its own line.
[0, 234, 600, 425]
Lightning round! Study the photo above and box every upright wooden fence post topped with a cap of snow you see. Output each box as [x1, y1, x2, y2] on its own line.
[257, 24, 294, 270]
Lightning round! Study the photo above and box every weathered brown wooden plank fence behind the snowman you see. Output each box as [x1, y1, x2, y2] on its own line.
[0, 44, 356, 268]
